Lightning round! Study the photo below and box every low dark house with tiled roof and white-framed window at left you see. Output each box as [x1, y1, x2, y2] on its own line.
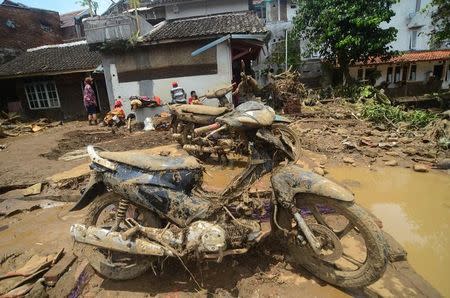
[0, 41, 109, 120]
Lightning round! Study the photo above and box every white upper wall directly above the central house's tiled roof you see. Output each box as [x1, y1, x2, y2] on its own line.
[166, 0, 248, 20]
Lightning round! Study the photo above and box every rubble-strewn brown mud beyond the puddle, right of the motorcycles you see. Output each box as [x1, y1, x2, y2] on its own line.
[291, 103, 450, 168]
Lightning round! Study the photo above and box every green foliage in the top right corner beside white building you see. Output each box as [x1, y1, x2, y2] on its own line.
[426, 0, 450, 48]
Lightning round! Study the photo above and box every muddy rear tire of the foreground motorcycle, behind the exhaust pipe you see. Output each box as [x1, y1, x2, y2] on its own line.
[75, 193, 161, 280]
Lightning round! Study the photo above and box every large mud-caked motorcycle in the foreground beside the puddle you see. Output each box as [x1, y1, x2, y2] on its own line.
[70, 101, 387, 287]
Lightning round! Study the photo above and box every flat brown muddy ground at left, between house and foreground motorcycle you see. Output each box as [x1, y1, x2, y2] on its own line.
[0, 121, 172, 187]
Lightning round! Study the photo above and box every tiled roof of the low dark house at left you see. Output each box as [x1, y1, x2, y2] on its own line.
[0, 42, 102, 78]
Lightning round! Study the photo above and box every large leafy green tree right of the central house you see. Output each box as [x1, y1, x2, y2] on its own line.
[294, 0, 397, 84]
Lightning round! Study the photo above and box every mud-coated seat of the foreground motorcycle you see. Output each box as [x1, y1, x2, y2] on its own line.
[98, 151, 202, 171]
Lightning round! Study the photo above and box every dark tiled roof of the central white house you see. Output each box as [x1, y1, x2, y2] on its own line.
[144, 12, 267, 42]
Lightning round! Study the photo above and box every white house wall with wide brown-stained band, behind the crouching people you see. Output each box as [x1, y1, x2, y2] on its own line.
[103, 41, 232, 114]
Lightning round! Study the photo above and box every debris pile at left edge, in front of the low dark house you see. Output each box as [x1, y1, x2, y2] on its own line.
[0, 112, 62, 138]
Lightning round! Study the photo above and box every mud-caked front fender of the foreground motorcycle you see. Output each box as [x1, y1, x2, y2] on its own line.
[271, 165, 355, 208]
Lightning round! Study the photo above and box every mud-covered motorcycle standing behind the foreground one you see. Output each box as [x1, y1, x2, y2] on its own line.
[169, 89, 300, 160]
